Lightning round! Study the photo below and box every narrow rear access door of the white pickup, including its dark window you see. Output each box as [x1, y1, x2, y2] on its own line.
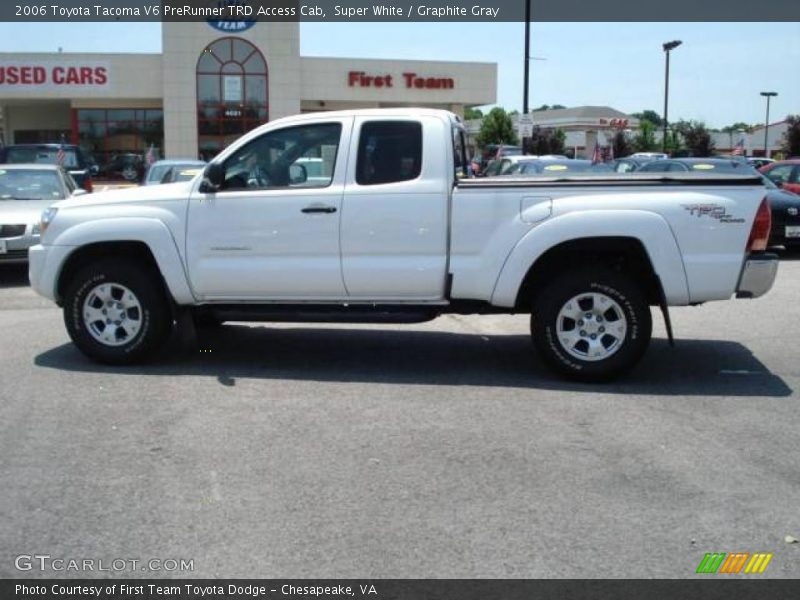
[341, 117, 452, 301]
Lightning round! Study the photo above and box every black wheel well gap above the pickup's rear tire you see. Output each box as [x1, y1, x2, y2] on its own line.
[515, 237, 662, 311]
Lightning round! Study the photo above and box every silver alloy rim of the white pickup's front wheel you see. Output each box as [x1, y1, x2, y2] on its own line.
[83, 283, 142, 346]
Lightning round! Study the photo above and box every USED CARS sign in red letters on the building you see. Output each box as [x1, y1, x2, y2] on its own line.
[0, 62, 109, 90]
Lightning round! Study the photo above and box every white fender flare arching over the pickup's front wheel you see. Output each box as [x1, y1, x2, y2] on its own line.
[53, 217, 195, 304]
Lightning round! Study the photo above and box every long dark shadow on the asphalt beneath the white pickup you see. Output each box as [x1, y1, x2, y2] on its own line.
[34, 324, 792, 397]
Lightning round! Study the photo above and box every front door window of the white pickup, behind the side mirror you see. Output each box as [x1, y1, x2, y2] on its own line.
[222, 123, 342, 190]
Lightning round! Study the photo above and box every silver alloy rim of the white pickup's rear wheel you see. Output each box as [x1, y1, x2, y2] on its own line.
[556, 292, 628, 362]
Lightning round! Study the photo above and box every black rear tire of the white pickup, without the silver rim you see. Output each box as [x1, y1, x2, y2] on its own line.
[531, 267, 653, 381]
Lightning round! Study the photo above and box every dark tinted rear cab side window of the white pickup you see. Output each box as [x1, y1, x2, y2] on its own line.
[356, 121, 422, 185]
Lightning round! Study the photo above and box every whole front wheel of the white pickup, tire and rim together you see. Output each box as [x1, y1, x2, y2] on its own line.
[64, 258, 172, 364]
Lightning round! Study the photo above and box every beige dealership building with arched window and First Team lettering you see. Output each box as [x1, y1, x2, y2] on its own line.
[0, 21, 497, 170]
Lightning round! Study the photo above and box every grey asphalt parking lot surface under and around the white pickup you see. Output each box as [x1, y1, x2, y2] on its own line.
[0, 255, 800, 578]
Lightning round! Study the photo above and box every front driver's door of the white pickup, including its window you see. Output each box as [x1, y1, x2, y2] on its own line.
[186, 118, 352, 301]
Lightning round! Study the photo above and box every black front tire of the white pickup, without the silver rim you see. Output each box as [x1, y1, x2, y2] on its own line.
[64, 258, 172, 365]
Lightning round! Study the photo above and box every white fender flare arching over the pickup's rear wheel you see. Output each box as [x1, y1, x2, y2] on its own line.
[492, 210, 689, 307]
